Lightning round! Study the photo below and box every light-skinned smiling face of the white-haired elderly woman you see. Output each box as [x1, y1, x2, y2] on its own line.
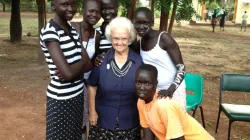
[111, 27, 129, 53]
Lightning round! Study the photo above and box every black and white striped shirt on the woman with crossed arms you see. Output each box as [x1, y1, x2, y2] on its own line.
[40, 20, 84, 100]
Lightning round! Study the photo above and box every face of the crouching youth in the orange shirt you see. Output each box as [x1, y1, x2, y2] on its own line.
[135, 69, 157, 103]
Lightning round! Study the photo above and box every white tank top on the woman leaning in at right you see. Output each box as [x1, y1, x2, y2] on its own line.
[140, 32, 177, 90]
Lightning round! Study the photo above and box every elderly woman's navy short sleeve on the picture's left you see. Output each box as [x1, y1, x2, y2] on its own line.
[87, 65, 102, 87]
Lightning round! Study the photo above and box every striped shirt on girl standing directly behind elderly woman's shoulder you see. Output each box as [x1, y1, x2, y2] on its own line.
[96, 27, 112, 53]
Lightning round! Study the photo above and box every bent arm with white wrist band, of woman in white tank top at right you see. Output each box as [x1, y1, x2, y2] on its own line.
[158, 33, 185, 98]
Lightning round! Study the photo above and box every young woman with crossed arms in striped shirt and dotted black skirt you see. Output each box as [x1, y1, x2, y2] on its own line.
[40, 0, 92, 140]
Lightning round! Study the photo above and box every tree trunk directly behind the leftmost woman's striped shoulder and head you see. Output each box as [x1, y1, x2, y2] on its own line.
[36, 0, 46, 65]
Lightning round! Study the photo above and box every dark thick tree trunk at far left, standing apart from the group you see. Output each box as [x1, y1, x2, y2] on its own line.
[10, 0, 22, 42]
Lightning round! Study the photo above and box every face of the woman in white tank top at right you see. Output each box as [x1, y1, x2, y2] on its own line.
[134, 11, 152, 37]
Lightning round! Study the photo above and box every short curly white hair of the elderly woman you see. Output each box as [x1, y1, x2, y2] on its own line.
[105, 17, 136, 43]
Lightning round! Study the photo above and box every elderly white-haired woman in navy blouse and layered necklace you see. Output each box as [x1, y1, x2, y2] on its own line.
[87, 17, 143, 140]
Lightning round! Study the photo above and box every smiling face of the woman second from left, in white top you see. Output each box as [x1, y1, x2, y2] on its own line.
[83, 1, 101, 25]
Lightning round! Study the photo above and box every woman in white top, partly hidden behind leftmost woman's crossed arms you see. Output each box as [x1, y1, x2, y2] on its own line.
[72, 0, 101, 138]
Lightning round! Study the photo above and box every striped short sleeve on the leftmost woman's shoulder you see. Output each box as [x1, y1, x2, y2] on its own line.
[40, 23, 59, 43]
